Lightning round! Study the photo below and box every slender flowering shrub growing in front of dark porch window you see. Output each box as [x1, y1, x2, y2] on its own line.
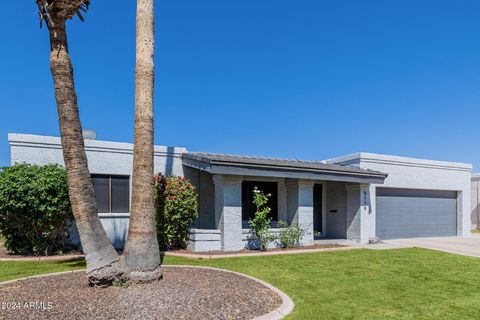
[249, 187, 273, 251]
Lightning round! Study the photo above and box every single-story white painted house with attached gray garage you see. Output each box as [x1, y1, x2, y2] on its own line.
[8, 134, 472, 251]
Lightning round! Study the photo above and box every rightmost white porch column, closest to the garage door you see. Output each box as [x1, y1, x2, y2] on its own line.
[346, 184, 375, 243]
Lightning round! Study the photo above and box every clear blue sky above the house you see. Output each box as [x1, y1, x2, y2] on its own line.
[0, 0, 480, 169]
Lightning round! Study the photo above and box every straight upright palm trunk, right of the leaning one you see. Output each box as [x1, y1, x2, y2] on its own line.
[124, 0, 162, 282]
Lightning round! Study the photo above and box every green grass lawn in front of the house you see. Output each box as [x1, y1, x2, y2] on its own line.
[0, 249, 480, 320]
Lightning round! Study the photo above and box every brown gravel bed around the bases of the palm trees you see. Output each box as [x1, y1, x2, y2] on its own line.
[0, 267, 282, 320]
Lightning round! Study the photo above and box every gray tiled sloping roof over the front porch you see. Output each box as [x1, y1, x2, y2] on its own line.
[182, 152, 387, 183]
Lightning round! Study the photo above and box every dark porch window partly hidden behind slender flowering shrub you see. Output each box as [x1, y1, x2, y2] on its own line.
[242, 181, 278, 221]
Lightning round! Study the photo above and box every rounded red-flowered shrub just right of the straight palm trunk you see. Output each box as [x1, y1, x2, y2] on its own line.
[154, 175, 198, 250]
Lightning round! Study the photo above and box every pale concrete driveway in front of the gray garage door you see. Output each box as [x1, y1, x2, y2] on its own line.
[380, 235, 480, 257]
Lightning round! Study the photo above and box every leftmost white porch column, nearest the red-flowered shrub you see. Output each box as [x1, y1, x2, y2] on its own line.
[213, 175, 244, 251]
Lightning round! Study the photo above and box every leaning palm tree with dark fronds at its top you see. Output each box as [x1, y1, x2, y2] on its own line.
[36, 0, 123, 285]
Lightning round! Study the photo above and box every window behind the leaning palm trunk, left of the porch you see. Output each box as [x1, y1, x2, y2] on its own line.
[92, 174, 130, 213]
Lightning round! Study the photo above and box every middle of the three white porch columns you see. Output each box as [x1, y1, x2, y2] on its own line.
[286, 180, 314, 246]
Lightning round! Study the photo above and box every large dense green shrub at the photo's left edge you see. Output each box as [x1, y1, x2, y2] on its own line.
[0, 164, 73, 255]
